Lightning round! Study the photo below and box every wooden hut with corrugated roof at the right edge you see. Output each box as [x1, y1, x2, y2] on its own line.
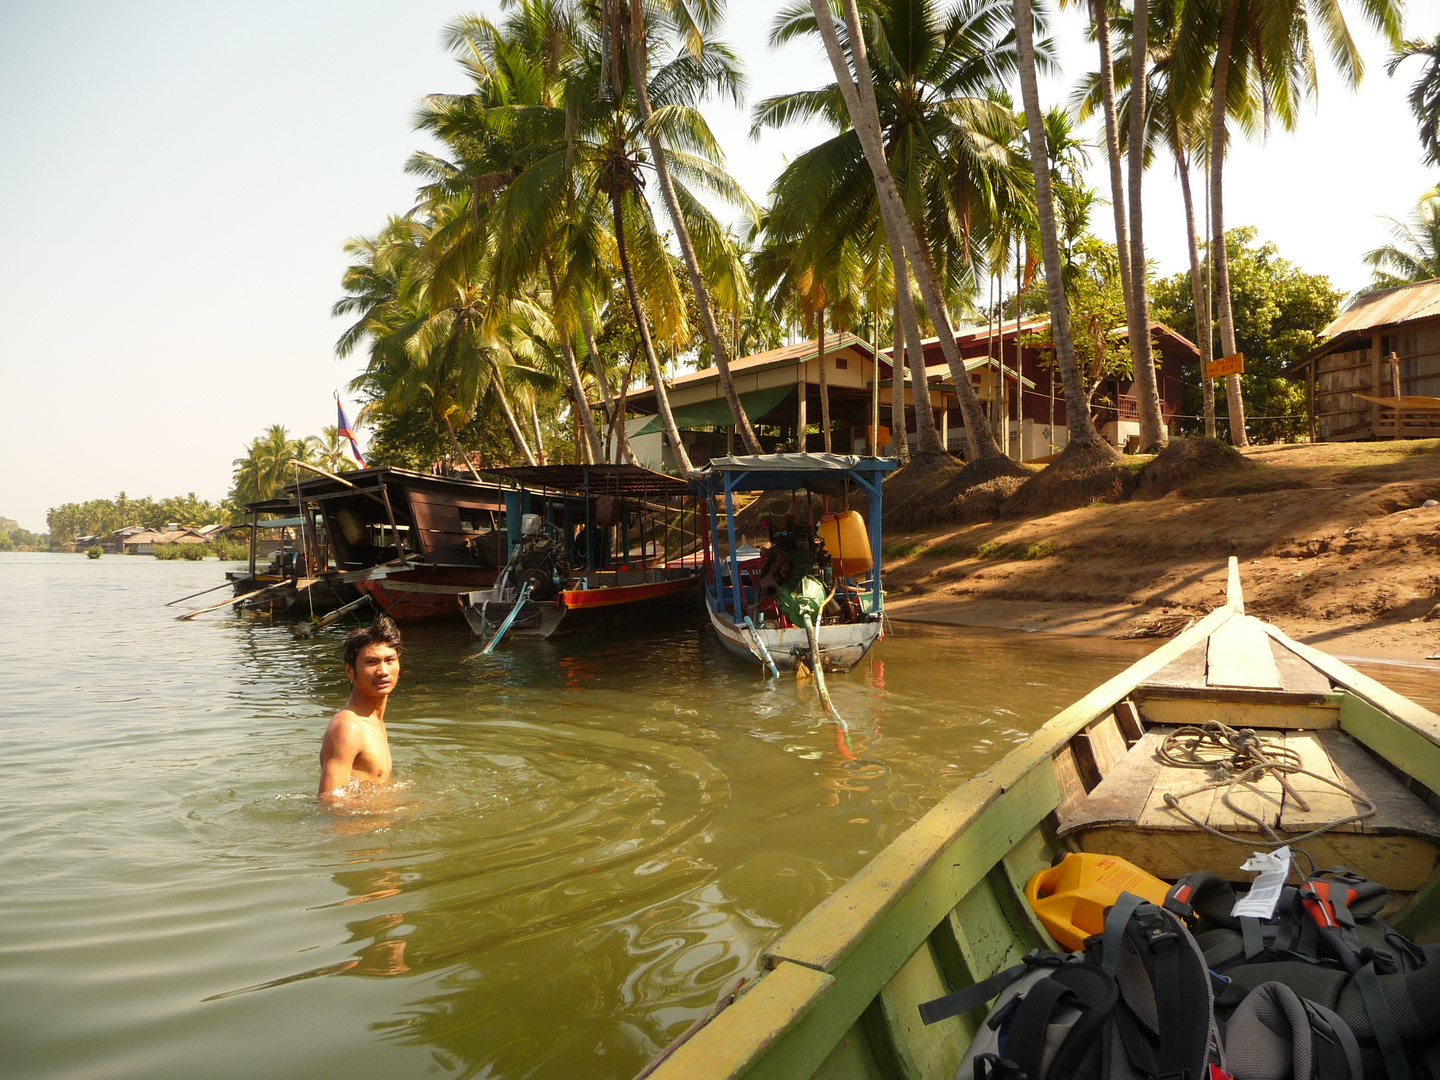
[1286, 278, 1440, 442]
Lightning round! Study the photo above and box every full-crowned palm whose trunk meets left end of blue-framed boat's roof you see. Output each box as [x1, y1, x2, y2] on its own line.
[449, 9, 747, 469]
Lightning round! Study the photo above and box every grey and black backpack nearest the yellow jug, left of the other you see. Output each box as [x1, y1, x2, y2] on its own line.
[920, 893, 1218, 1080]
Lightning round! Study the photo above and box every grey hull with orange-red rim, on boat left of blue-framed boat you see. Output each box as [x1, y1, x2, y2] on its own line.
[461, 570, 700, 638]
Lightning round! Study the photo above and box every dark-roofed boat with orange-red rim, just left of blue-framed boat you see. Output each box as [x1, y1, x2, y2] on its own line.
[461, 464, 700, 638]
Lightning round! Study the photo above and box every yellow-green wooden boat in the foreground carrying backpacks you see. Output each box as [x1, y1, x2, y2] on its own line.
[642, 559, 1440, 1080]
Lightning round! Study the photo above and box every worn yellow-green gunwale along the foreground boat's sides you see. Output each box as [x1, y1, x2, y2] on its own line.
[644, 578, 1440, 1080]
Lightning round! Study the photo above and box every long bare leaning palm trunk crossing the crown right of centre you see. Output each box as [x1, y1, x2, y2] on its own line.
[811, 0, 1005, 459]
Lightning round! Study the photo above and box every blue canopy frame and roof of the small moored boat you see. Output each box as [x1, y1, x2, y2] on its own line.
[690, 454, 900, 626]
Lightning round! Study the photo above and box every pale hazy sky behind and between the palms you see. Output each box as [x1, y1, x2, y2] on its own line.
[0, 0, 1440, 531]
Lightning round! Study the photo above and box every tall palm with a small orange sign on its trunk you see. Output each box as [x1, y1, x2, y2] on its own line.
[1175, 0, 1401, 446]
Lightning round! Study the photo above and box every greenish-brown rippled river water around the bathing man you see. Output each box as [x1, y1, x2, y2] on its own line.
[0, 554, 1428, 1080]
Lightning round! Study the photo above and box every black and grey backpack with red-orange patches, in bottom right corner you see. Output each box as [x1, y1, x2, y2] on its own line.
[1165, 867, 1440, 1080]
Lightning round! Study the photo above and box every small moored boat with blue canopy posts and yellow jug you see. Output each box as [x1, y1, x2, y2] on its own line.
[690, 454, 896, 671]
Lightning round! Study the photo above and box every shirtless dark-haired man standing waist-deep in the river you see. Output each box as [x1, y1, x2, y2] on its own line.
[320, 615, 400, 799]
